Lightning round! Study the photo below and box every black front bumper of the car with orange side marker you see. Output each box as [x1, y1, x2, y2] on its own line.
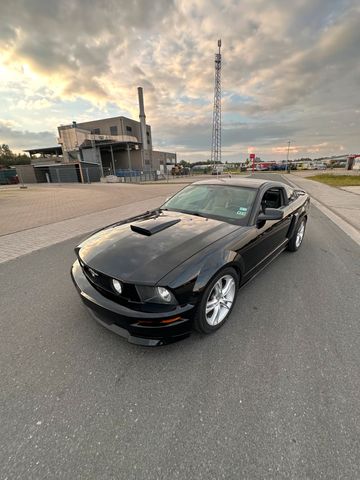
[71, 260, 195, 347]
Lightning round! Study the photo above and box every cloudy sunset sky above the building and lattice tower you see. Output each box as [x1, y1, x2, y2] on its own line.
[0, 0, 360, 161]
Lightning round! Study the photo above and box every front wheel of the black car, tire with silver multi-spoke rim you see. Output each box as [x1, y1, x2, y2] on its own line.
[194, 267, 239, 333]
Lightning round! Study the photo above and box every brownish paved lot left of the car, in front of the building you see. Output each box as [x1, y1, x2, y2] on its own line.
[0, 183, 180, 236]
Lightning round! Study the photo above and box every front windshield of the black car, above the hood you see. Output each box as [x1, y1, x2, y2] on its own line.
[161, 184, 256, 225]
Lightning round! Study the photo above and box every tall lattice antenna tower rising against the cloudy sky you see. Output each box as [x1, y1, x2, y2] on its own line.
[211, 40, 221, 168]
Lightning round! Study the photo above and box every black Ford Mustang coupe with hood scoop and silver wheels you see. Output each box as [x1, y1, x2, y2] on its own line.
[71, 178, 310, 346]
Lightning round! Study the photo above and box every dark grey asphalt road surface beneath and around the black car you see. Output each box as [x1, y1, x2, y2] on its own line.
[0, 174, 360, 480]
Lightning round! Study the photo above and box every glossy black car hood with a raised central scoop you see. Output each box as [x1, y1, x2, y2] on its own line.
[78, 211, 240, 285]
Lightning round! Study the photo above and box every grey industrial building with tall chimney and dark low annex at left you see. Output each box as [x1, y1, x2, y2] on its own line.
[26, 87, 176, 182]
